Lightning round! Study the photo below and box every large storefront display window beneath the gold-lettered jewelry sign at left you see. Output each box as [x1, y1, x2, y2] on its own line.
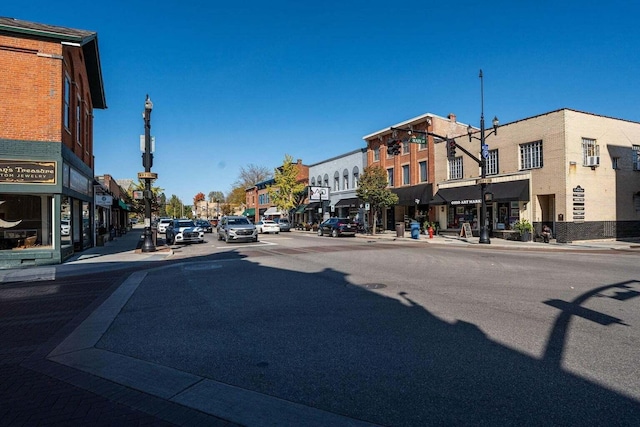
[0, 194, 52, 250]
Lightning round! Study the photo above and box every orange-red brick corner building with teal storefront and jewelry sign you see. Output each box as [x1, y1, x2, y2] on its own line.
[0, 18, 106, 267]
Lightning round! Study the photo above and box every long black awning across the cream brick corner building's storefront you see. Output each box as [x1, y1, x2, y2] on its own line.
[431, 179, 529, 205]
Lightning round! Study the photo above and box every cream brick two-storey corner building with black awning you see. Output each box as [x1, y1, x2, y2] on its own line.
[432, 109, 640, 242]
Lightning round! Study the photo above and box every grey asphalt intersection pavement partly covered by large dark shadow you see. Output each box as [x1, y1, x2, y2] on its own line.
[5, 233, 640, 425]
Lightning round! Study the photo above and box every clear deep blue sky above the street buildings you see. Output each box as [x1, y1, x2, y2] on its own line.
[0, 0, 640, 204]
